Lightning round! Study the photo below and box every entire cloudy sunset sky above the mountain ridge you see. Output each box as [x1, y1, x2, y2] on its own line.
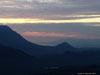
[0, 0, 100, 46]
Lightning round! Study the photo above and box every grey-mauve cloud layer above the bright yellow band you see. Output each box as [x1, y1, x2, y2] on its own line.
[0, 0, 100, 20]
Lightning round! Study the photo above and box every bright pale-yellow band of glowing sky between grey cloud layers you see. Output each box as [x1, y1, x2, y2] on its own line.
[0, 18, 100, 24]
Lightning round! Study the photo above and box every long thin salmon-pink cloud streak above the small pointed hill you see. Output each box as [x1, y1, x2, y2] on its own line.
[22, 32, 100, 39]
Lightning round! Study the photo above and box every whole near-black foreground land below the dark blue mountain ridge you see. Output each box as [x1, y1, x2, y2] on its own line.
[0, 45, 100, 75]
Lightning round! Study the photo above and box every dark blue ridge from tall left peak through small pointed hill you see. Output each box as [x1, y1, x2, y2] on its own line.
[0, 25, 73, 55]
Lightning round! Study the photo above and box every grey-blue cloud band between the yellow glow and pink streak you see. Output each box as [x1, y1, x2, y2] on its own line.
[9, 23, 100, 36]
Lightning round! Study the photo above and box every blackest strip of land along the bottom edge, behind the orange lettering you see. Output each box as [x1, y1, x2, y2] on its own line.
[33, 65, 100, 75]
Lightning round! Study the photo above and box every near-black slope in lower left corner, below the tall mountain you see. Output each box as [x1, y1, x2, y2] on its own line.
[0, 45, 33, 75]
